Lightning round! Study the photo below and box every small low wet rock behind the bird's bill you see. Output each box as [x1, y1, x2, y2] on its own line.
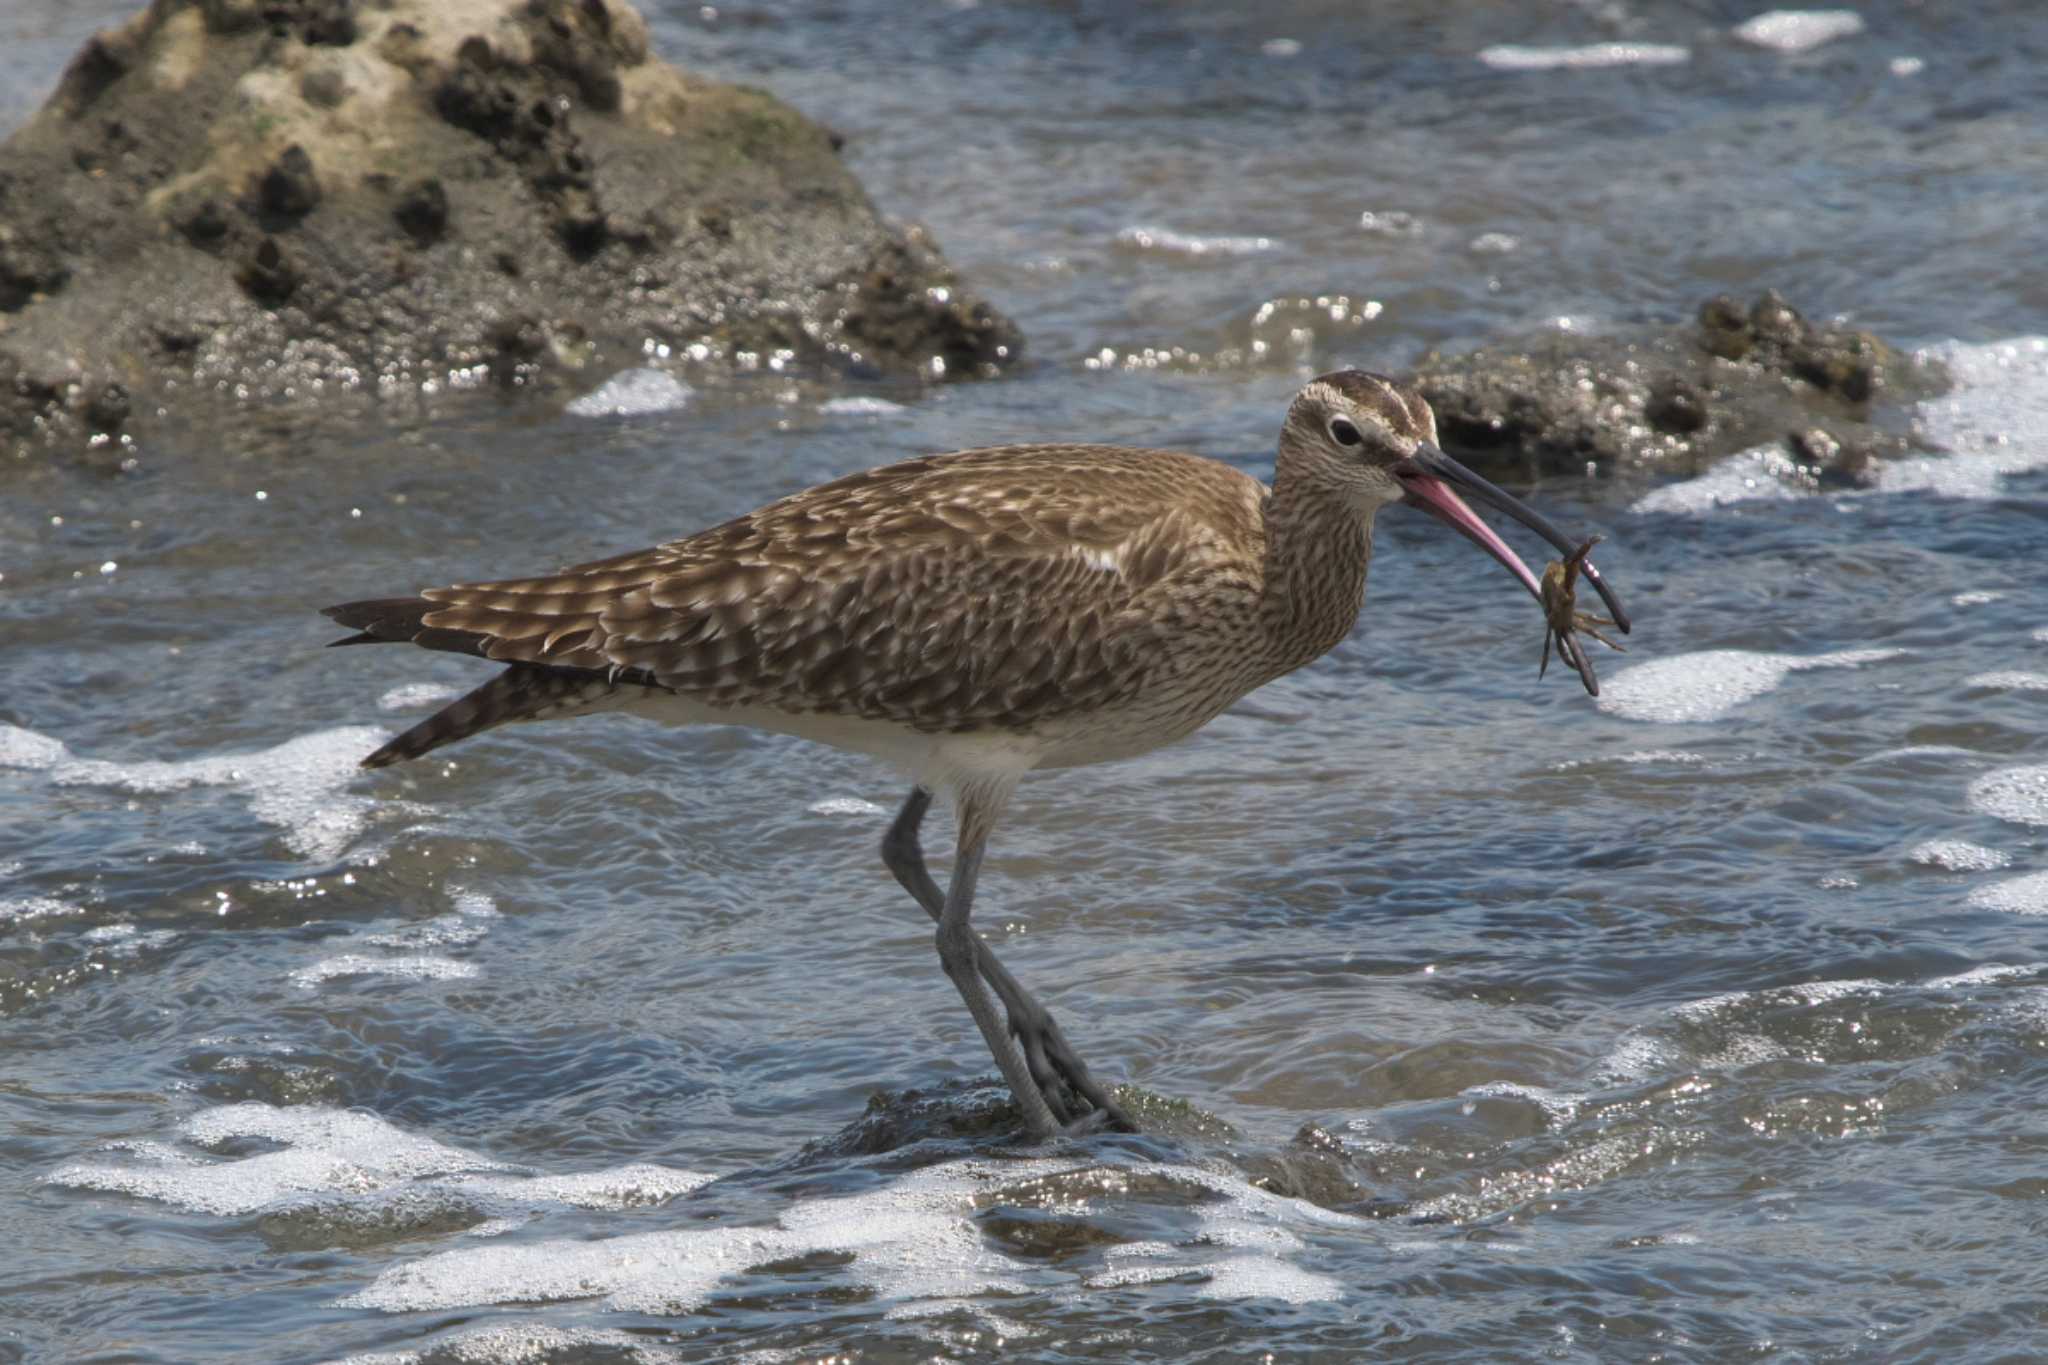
[1417, 291, 1948, 487]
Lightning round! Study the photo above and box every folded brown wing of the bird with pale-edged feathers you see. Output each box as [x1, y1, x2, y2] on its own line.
[420, 446, 1264, 729]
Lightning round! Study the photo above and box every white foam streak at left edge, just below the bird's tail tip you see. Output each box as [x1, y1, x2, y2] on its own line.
[0, 726, 387, 862]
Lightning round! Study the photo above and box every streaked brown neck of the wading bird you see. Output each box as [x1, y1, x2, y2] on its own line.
[1260, 469, 1372, 671]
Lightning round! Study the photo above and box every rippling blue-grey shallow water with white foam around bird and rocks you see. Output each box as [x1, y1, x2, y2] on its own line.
[0, 0, 2048, 1361]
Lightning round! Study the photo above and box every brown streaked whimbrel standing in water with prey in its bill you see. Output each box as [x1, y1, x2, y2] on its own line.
[326, 370, 1628, 1136]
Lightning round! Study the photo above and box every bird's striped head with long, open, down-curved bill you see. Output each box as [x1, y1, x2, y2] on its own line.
[1280, 370, 1628, 630]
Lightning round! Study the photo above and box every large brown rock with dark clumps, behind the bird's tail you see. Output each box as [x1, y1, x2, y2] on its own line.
[0, 0, 1020, 452]
